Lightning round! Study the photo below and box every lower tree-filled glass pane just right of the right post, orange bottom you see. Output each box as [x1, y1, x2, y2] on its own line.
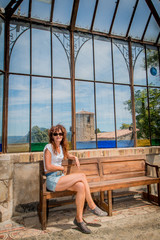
[134, 87, 150, 147]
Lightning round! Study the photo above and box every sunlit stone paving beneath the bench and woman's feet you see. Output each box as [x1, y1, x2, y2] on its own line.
[0, 197, 160, 240]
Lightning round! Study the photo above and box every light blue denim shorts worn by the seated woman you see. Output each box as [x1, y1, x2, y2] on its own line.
[46, 171, 64, 192]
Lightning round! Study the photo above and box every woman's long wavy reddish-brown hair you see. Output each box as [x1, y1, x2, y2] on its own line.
[48, 124, 68, 159]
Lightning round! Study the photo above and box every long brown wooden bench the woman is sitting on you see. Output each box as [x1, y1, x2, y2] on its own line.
[38, 155, 160, 230]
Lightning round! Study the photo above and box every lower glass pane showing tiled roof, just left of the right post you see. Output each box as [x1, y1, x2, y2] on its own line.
[115, 85, 134, 148]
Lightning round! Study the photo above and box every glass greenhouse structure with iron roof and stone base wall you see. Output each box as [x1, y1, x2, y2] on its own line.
[0, 0, 160, 223]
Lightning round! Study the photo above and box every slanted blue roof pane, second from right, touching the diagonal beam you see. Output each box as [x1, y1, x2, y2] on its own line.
[129, 0, 150, 39]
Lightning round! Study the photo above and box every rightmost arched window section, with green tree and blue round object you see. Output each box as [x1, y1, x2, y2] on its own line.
[132, 44, 160, 146]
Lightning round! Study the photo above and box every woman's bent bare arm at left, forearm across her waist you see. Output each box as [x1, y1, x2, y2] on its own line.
[45, 149, 64, 173]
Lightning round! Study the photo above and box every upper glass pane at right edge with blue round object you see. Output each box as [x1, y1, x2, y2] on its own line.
[147, 47, 160, 86]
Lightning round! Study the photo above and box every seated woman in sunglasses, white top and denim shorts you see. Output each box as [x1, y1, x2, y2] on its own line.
[44, 125, 107, 233]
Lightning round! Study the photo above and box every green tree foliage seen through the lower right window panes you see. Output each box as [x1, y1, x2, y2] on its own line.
[122, 88, 160, 139]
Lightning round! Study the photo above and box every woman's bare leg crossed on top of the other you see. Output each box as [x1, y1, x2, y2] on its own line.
[55, 173, 96, 209]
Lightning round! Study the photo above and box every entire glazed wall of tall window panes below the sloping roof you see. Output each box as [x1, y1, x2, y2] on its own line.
[3, 20, 160, 152]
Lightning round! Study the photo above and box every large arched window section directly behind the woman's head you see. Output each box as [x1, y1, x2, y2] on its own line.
[8, 22, 71, 152]
